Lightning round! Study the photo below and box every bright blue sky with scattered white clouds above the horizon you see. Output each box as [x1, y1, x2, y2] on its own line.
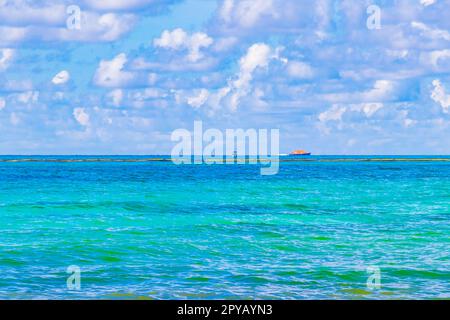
[0, 0, 450, 155]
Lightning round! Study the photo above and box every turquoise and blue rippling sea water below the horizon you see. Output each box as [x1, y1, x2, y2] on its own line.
[0, 156, 450, 299]
